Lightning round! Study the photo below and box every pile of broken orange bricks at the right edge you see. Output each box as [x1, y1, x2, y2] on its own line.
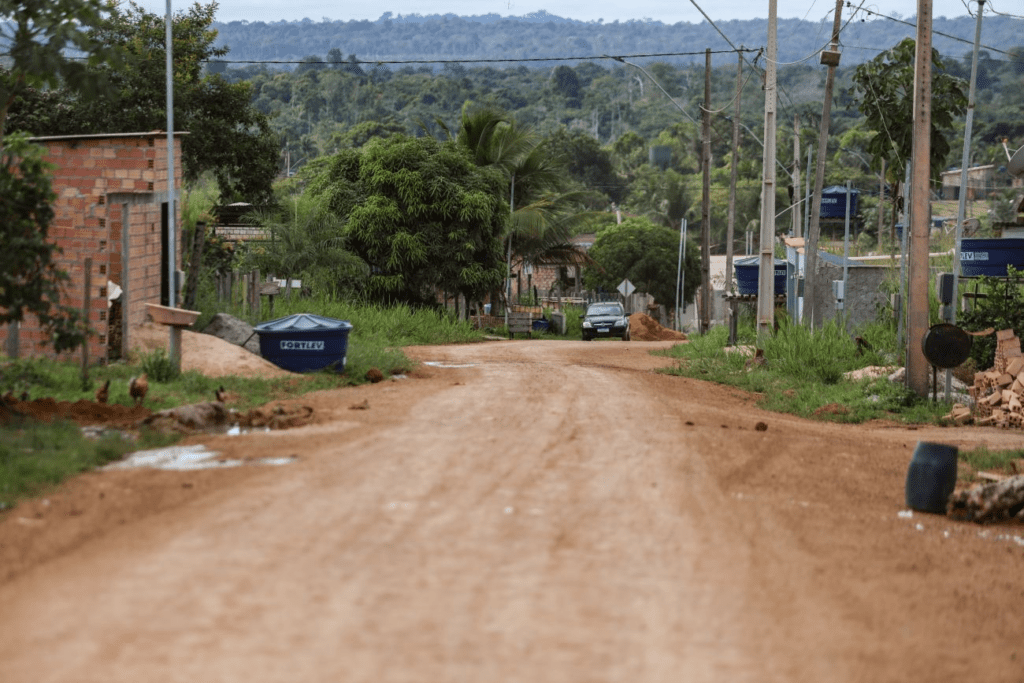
[947, 330, 1024, 429]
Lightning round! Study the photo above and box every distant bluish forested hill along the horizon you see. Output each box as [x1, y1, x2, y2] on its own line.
[213, 11, 1024, 66]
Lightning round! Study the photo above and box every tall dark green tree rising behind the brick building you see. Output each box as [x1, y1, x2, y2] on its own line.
[4, 0, 280, 203]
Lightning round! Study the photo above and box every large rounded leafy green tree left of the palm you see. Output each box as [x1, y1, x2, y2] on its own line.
[307, 135, 508, 304]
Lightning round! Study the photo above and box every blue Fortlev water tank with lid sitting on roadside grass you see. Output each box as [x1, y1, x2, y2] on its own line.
[253, 313, 352, 373]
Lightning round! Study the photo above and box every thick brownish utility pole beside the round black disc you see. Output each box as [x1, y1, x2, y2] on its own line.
[906, 0, 932, 396]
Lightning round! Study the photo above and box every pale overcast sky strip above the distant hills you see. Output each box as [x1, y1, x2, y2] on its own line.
[139, 0, 974, 24]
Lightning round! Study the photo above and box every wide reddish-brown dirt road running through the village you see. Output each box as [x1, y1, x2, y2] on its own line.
[0, 341, 1024, 683]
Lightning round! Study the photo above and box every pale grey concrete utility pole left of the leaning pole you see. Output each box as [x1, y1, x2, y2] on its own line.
[758, 0, 778, 339]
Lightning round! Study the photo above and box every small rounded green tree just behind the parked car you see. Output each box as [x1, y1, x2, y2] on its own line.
[584, 218, 700, 308]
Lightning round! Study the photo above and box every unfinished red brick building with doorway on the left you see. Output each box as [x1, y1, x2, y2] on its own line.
[0, 131, 181, 364]
